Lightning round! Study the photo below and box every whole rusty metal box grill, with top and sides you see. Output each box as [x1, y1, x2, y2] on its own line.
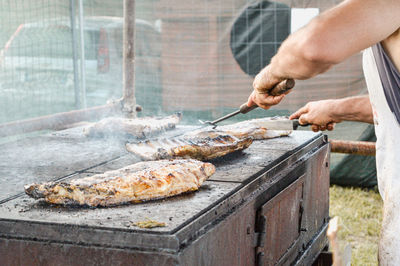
[0, 128, 329, 265]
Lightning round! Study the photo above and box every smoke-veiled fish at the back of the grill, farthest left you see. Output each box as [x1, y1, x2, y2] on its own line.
[84, 113, 182, 138]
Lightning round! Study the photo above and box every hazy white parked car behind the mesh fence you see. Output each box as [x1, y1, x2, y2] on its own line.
[0, 16, 161, 115]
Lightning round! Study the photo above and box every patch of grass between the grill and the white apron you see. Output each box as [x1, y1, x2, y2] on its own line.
[329, 186, 382, 265]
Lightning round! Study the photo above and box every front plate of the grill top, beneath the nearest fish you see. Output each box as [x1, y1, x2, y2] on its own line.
[0, 179, 240, 232]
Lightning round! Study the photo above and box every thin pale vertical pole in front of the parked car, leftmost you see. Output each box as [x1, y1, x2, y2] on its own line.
[69, 0, 81, 109]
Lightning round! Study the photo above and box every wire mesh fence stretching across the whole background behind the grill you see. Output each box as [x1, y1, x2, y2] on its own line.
[0, 0, 376, 185]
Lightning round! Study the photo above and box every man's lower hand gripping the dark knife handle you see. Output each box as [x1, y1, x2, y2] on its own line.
[289, 100, 342, 132]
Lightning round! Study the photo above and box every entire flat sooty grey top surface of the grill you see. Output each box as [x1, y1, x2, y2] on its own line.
[0, 125, 320, 248]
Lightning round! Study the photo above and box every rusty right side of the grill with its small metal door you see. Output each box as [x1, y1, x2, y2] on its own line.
[179, 138, 329, 265]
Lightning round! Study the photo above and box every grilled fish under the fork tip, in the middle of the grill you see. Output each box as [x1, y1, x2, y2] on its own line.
[126, 131, 253, 160]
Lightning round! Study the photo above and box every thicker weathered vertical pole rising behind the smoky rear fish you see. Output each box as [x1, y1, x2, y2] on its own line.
[122, 0, 136, 117]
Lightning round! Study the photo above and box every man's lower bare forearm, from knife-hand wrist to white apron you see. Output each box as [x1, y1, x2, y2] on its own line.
[332, 95, 374, 124]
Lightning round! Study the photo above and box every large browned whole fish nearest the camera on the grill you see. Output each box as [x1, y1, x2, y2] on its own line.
[25, 159, 215, 207]
